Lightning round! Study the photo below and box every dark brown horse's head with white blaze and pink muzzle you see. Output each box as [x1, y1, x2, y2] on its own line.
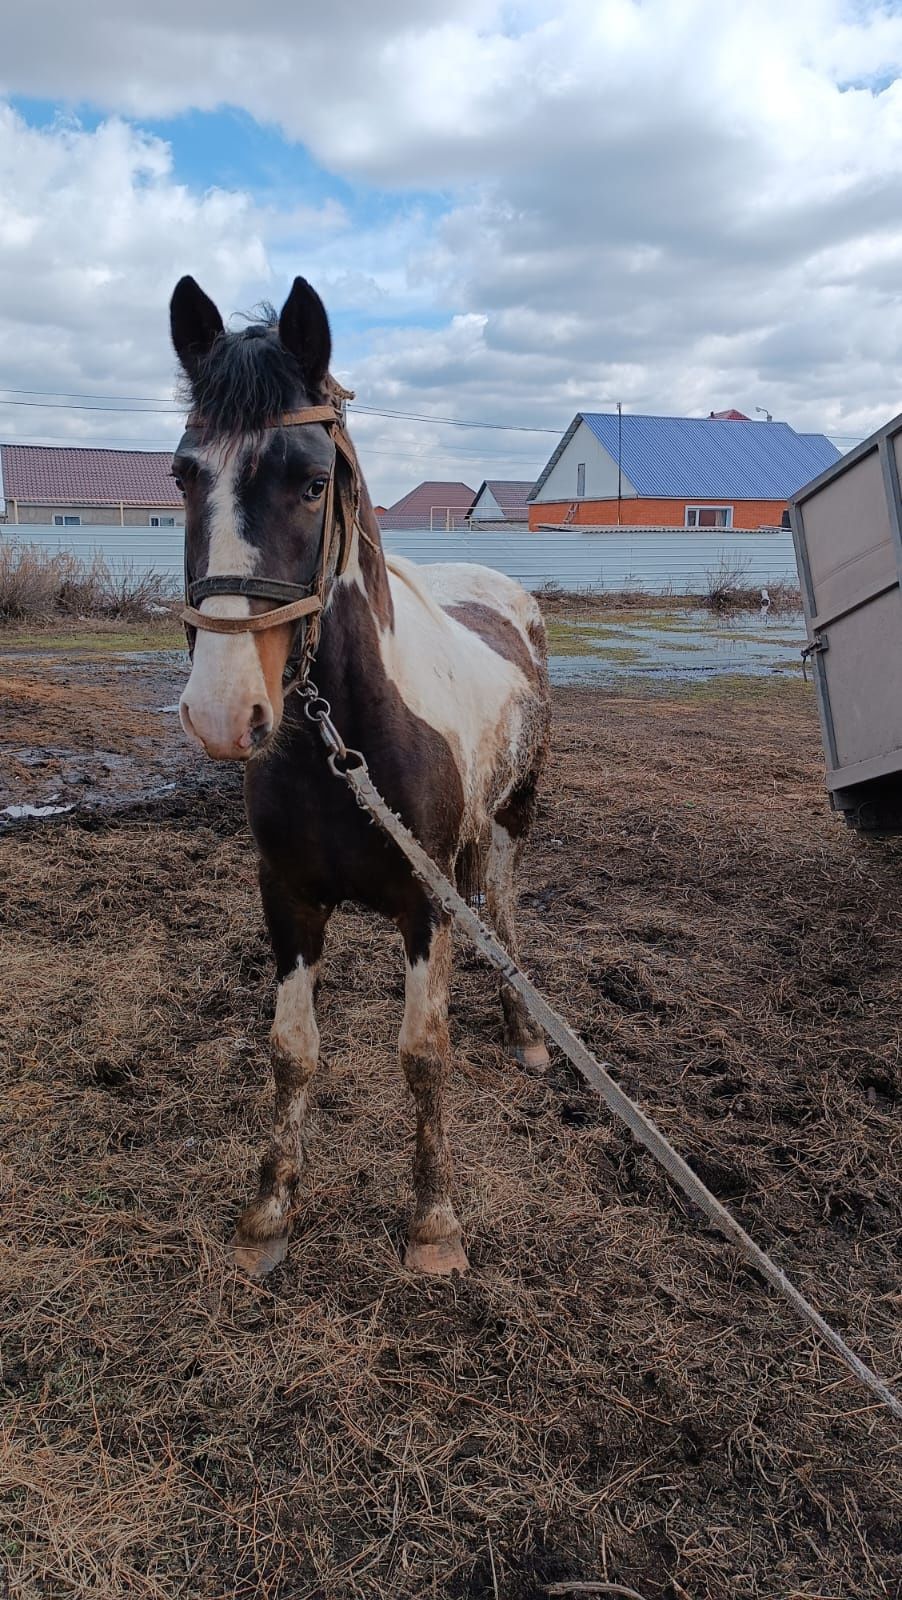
[171, 278, 336, 760]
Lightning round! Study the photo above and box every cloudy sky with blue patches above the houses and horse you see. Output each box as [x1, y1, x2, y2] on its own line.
[0, 0, 902, 504]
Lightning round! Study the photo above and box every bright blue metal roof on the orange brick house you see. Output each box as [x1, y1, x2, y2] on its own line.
[581, 411, 840, 501]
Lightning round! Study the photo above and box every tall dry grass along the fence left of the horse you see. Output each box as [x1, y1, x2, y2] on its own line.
[0, 550, 173, 622]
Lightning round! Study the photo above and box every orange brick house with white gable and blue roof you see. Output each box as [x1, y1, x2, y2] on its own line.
[529, 411, 840, 528]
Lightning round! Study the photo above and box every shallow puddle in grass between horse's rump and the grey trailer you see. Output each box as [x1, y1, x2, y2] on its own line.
[549, 611, 806, 685]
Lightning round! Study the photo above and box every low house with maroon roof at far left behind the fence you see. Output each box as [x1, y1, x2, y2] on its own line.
[0, 445, 186, 528]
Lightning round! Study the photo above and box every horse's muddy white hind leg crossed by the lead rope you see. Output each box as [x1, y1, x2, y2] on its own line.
[486, 782, 549, 1070]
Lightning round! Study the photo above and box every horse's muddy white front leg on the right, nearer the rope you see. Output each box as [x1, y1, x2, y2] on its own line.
[398, 901, 469, 1274]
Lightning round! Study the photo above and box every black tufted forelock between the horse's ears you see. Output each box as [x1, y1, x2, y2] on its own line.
[181, 304, 313, 440]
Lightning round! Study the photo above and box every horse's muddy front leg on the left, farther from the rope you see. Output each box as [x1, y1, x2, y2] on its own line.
[232, 862, 331, 1278]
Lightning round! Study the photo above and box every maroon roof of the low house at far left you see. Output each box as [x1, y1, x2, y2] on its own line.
[0, 445, 182, 507]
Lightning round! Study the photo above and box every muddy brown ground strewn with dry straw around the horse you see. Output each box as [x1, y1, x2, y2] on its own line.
[0, 636, 902, 1600]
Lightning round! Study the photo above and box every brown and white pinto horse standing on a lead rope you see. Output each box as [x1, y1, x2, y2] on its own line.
[170, 277, 550, 1277]
